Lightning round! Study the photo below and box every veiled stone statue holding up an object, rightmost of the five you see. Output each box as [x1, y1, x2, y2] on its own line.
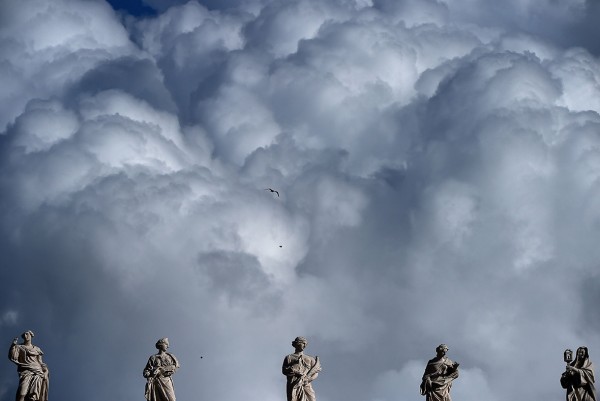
[560, 347, 596, 401]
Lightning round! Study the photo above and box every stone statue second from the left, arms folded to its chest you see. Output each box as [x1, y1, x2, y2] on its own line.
[144, 338, 179, 401]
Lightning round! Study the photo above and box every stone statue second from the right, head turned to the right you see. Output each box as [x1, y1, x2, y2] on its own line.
[421, 344, 459, 401]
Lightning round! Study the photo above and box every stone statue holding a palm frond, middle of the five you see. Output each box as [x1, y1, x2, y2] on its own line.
[281, 337, 321, 401]
